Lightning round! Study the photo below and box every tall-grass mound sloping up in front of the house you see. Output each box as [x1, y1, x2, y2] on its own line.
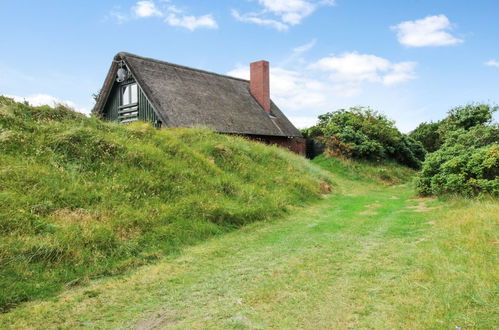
[0, 97, 327, 312]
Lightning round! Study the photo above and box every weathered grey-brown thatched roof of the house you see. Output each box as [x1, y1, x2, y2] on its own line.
[96, 52, 301, 137]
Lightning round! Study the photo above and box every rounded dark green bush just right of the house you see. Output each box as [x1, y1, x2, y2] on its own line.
[303, 107, 425, 169]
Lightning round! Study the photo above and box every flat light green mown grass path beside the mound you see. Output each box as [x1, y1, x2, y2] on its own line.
[0, 166, 499, 329]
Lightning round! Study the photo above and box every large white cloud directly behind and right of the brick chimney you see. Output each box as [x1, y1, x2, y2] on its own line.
[227, 52, 416, 110]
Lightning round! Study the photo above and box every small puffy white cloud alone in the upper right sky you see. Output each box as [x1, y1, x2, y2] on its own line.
[391, 15, 463, 47]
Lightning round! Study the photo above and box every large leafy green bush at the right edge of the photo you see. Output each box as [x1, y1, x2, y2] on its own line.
[411, 104, 499, 196]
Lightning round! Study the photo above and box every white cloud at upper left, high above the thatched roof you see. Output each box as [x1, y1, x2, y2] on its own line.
[109, 0, 218, 31]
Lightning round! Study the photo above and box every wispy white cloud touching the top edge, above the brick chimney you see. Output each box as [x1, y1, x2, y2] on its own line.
[232, 0, 334, 31]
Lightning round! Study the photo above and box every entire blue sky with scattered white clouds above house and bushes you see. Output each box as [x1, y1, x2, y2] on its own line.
[0, 0, 499, 132]
